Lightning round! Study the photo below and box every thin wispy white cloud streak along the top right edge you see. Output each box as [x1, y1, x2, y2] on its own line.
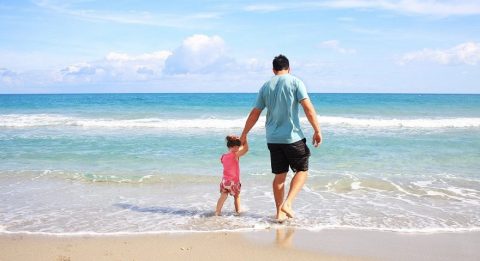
[244, 0, 480, 16]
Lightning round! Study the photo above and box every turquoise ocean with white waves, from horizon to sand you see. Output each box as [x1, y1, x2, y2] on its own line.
[0, 93, 480, 235]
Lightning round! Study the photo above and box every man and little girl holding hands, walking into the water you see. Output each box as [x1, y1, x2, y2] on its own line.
[215, 55, 322, 222]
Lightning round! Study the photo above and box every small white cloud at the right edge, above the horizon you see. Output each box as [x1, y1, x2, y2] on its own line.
[399, 42, 480, 65]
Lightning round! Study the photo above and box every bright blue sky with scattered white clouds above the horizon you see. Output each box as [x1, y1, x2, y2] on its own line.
[0, 0, 480, 93]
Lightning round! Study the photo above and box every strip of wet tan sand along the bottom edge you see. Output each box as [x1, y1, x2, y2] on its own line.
[0, 227, 480, 261]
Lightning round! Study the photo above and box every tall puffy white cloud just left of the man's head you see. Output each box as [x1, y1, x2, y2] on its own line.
[164, 34, 235, 74]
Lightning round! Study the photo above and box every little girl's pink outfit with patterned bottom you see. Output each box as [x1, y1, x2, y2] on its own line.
[220, 152, 242, 196]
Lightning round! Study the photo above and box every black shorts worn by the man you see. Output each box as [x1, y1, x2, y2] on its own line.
[267, 139, 310, 174]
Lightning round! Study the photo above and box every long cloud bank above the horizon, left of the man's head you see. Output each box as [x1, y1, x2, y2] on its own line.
[7, 34, 271, 92]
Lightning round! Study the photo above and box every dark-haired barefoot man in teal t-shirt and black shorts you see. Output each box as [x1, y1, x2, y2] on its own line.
[240, 55, 322, 221]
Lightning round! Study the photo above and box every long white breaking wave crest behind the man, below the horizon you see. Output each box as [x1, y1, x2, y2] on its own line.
[0, 114, 480, 129]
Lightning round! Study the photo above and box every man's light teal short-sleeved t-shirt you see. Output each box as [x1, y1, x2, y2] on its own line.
[255, 74, 308, 144]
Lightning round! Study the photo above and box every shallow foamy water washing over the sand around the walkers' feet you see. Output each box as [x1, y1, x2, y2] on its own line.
[0, 170, 480, 236]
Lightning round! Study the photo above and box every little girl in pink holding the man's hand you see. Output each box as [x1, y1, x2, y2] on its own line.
[215, 136, 248, 216]
